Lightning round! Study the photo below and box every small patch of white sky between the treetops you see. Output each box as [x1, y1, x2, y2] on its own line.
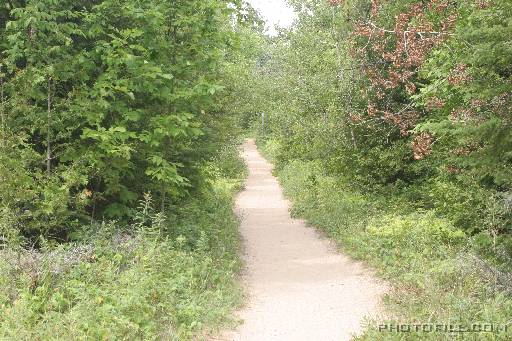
[247, 0, 295, 35]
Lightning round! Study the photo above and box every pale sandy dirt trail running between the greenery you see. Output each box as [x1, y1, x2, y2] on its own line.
[215, 140, 385, 341]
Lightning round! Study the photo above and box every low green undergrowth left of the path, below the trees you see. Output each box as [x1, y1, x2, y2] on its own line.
[0, 143, 245, 340]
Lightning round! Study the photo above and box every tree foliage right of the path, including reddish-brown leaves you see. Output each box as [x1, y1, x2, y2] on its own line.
[254, 0, 512, 233]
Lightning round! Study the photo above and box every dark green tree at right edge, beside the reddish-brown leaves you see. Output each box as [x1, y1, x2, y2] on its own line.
[416, 1, 512, 190]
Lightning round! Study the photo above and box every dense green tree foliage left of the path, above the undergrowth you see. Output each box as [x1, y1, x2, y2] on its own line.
[0, 0, 257, 240]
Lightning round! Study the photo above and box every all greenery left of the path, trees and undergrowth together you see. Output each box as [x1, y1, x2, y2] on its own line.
[0, 0, 261, 340]
